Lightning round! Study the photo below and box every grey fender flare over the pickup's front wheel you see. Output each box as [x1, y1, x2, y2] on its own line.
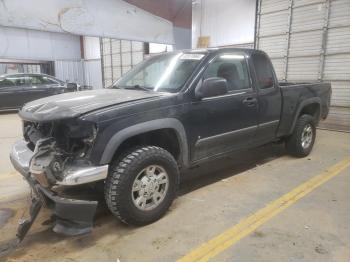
[100, 118, 189, 167]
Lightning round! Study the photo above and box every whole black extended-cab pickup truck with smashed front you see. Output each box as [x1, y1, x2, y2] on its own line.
[10, 48, 331, 239]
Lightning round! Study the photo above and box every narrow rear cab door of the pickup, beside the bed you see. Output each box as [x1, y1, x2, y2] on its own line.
[250, 52, 282, 144]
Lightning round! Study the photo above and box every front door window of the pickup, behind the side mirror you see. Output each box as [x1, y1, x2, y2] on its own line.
[203, 53, 250, 92]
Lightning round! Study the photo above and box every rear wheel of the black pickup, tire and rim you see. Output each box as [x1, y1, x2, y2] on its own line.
[286, 115, 316, 157]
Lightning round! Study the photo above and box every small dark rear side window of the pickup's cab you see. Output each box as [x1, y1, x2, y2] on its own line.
[252, 54, 274, 89]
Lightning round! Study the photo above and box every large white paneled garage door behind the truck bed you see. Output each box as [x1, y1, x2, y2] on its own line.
[256, 0, 350, 131]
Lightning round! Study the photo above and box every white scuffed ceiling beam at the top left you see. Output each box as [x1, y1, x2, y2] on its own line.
[0, 0, 174, 44]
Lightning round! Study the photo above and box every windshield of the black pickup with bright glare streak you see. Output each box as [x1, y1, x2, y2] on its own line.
[112, 53, 204, 93]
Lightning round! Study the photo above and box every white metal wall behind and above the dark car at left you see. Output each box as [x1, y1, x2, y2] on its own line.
[0, 26, 84, 85]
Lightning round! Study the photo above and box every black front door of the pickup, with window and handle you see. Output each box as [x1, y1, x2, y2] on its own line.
[188, 52, 258, 161]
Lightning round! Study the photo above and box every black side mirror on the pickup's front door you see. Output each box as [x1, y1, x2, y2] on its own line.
[194, 77, 228, 99]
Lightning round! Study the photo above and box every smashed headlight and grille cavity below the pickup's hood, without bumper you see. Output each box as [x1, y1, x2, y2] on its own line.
[23, 119, 97, 186]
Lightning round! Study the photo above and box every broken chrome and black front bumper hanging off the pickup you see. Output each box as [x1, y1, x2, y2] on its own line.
[10, 140, 108, 240]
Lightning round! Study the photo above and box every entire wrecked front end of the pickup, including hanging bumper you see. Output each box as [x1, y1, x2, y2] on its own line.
[10, 119, 108, 240]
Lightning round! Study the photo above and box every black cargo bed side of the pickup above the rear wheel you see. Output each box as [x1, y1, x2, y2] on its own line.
[277, 82, 331, 137]
